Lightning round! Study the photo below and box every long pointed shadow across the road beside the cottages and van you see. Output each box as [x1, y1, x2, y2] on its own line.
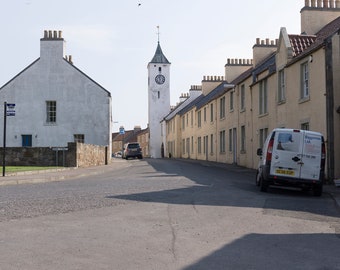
[107, 159, 340, 220]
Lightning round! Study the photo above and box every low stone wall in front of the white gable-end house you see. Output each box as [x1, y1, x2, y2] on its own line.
[0, 143, 109, 167]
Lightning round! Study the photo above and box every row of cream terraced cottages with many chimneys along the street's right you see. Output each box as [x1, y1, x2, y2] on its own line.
[162, 1, 340, 179]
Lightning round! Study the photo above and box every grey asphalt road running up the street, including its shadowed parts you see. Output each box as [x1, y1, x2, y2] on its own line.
[0, 159, 340, 270]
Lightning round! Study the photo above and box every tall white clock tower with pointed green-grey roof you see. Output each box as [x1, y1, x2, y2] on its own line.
[148, 37, 171, 158]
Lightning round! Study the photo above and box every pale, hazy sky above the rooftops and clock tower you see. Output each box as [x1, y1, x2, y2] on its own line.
[0, 0, 305, 132]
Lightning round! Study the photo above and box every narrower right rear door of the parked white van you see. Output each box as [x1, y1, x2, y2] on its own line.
[300, 132, 322, 180]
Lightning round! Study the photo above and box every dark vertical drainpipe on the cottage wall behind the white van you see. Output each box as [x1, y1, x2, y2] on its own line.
[325, 35, 334, 183]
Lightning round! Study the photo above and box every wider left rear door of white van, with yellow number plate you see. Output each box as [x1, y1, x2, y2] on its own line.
[270, 129, 303, 178]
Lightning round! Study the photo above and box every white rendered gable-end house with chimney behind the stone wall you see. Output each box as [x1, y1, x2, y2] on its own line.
[0, 31, 112, 149]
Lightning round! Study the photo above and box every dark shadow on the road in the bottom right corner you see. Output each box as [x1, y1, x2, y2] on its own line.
[183, 234, 340, 270]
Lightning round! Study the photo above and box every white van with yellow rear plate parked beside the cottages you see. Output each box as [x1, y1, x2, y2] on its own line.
[256, 128, 326, 196]
